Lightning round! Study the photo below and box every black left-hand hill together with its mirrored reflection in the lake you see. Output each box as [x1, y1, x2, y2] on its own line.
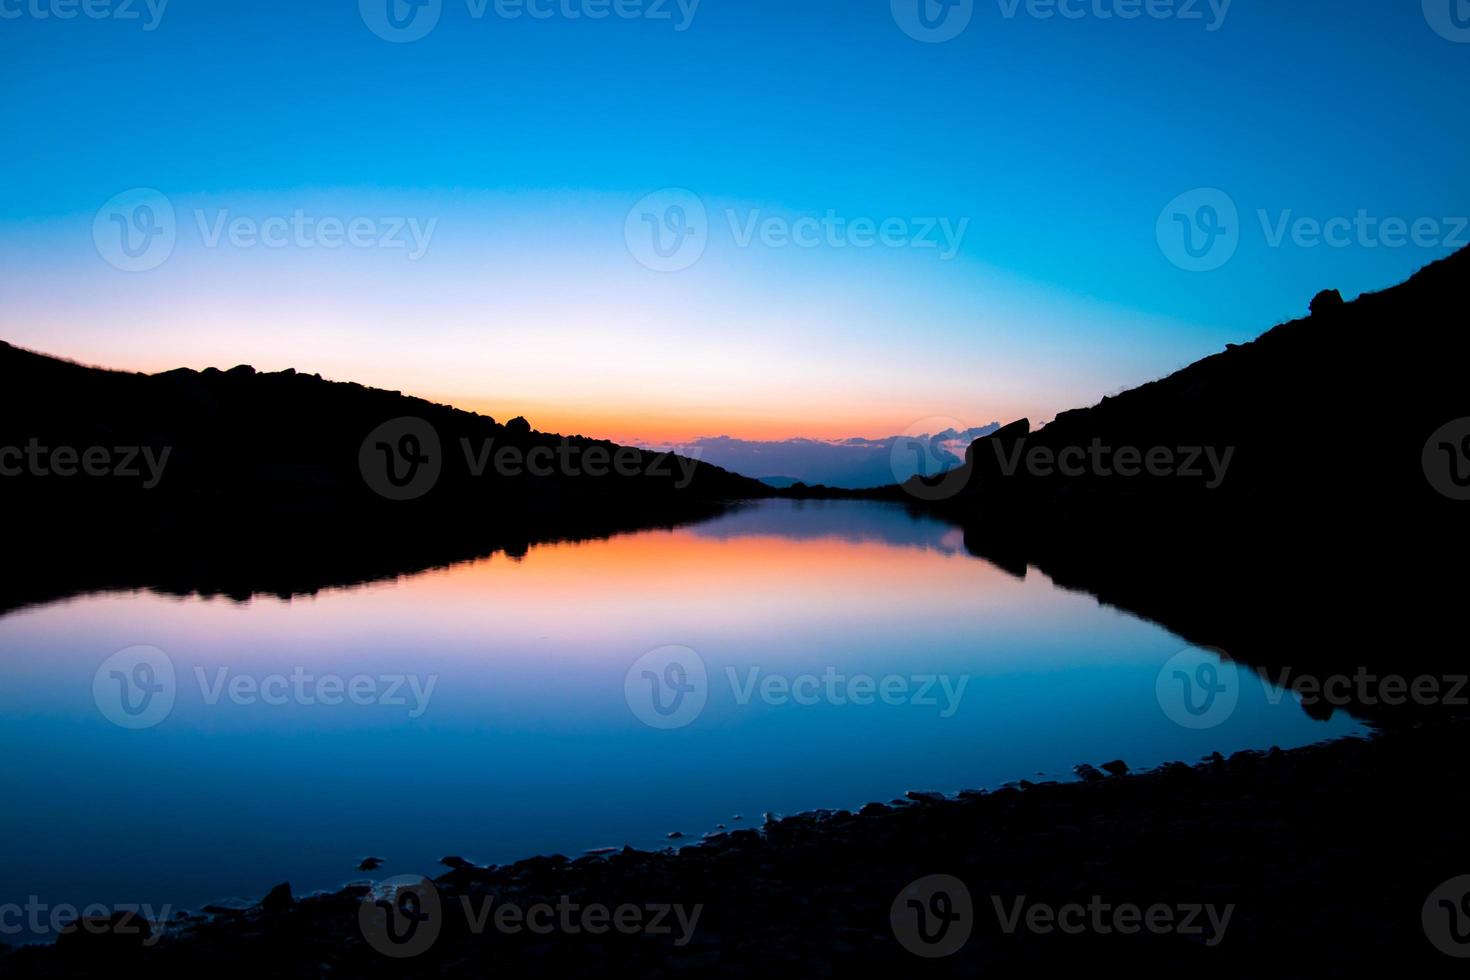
[0, 342, 773, 610]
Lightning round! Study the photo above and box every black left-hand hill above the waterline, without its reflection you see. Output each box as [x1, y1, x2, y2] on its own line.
[0, 344, 766, 513]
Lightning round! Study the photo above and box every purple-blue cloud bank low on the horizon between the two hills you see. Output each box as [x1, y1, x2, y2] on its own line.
[648, 422, 1000, 489]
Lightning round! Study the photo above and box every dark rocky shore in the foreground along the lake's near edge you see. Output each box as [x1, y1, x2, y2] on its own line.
[11, 721, 1470, 977]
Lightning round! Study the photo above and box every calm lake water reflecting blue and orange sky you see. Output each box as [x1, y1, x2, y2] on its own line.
[0, 502, 1355, 942]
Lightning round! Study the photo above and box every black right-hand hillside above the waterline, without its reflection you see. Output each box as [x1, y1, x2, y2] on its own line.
[913, 243, 1470, 532]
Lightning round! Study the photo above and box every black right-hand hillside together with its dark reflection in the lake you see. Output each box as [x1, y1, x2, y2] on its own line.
[908, 250, 1470, 728]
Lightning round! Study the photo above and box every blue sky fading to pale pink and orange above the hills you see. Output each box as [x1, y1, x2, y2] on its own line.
[0, 0, 1470, 442]
